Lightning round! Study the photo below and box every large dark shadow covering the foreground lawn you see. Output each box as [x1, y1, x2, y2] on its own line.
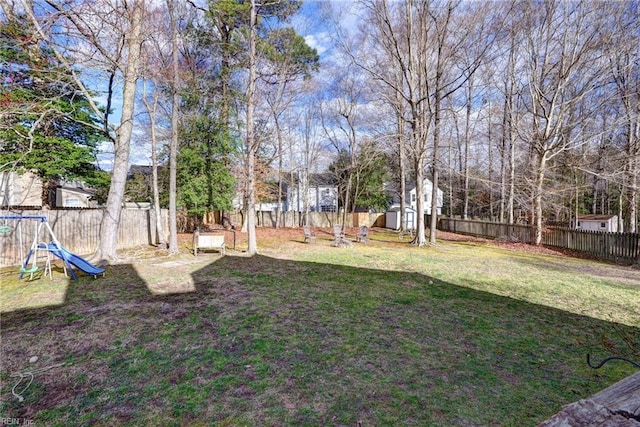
[0, 255, 633, 425]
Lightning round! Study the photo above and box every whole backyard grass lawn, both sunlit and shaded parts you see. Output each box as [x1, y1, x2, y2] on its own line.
[0, 230, 640, 426]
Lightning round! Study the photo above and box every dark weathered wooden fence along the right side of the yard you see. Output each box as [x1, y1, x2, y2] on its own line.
[438, 218, 640, 263]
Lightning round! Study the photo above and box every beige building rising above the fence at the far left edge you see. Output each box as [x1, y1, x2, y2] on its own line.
[0, 172, 42, 207]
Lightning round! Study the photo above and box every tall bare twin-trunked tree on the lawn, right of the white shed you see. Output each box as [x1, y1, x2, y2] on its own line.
[352, 0, 489, 246]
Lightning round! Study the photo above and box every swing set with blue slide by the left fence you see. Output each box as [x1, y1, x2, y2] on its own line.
[0, 215, 105, 280]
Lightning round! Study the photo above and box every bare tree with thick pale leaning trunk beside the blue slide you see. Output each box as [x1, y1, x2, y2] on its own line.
[25, 0, 145, 261]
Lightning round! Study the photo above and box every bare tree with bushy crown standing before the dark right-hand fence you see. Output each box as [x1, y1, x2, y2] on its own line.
[521, 2, 603, 244]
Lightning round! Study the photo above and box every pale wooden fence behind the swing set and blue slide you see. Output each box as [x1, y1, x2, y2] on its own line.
[0, 209, 168, 267]
